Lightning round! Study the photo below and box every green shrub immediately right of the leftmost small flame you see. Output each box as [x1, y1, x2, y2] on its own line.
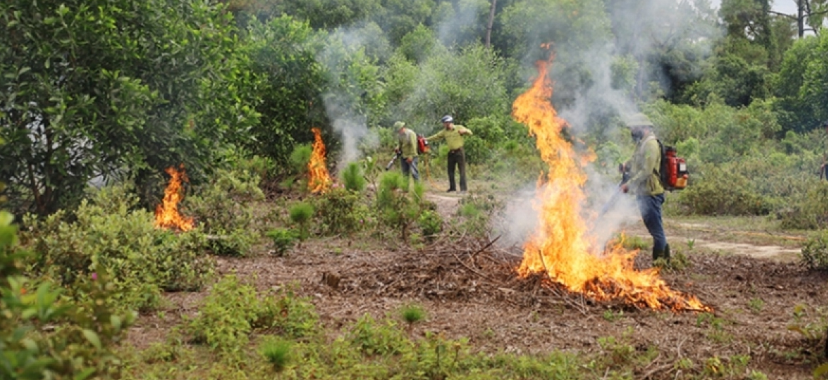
[184, 169, 264, 256]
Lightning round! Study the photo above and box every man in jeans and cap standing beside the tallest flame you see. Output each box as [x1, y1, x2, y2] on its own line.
[621, 113, 670, 261]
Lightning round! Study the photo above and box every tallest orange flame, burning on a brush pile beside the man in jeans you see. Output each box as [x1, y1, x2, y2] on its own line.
[512, 55, 712, 311]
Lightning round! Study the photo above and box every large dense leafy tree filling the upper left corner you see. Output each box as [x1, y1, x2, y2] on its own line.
[0, 0, 256, 215]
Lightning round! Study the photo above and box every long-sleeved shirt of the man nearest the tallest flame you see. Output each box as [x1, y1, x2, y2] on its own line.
[627, 135, 664, 196]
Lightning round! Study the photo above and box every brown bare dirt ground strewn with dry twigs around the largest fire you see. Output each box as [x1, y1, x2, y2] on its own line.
[130, 189, 828, 379]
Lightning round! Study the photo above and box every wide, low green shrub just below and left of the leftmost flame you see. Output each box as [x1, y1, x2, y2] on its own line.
[24, 185, 214, 310]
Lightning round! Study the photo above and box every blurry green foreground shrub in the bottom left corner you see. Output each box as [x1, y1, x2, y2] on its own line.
[0, 211, 135, 379]
